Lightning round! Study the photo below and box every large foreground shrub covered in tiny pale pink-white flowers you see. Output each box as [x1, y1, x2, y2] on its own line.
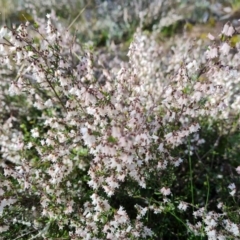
[0, 1, 240, 239]
